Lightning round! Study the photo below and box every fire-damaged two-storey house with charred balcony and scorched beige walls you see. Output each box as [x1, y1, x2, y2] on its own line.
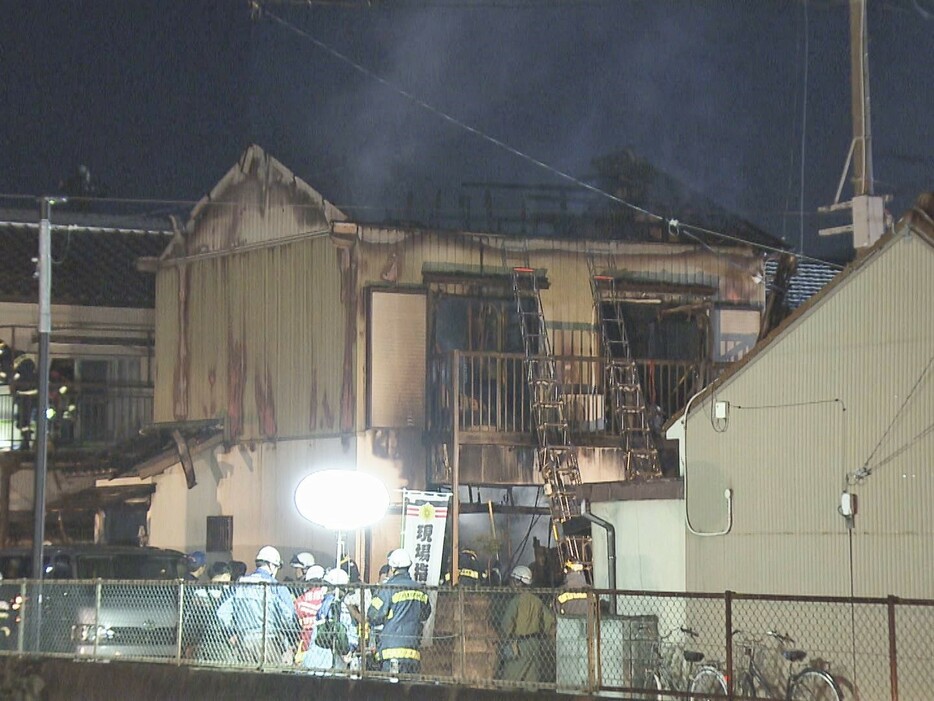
[141, 146, 784, 588]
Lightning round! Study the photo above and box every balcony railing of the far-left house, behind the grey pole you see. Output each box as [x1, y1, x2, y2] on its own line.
[0, 384, 153, 451]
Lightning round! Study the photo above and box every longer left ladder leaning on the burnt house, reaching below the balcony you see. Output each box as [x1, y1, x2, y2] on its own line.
[512, 267, 593, 572]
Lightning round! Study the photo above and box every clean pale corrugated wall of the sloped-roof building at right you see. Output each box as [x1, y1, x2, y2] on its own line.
[686, 237, 934, 597]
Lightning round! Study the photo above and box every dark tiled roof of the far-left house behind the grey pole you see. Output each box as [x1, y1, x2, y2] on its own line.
[0, 210, 171, 309]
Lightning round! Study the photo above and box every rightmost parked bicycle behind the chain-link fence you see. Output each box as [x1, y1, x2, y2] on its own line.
[733, 630, 843, 701]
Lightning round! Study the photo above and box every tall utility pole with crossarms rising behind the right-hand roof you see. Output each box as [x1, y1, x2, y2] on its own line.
[818, 0, 885, 249]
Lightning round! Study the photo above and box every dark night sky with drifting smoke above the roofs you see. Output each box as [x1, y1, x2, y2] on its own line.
[0, 0, 934, 256]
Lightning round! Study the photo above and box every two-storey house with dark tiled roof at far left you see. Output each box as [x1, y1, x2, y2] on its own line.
[0, 206, 172, 543]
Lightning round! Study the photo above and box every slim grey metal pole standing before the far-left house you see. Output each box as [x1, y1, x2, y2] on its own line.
[32, 197, 66, 580]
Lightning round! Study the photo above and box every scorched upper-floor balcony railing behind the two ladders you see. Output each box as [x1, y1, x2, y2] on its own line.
[427, 352, 713, 435]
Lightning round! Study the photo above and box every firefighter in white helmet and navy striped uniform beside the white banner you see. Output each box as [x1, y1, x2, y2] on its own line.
[367, 548, 431, 674]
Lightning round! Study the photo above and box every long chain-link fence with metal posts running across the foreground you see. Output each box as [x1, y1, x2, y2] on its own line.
[0, 580, 934, 701]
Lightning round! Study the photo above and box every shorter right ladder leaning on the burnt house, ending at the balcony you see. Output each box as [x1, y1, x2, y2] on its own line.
[587, 257, 661, 479]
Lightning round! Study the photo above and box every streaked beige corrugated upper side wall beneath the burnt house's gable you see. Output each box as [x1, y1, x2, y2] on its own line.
[156, 237, 345, 439]
